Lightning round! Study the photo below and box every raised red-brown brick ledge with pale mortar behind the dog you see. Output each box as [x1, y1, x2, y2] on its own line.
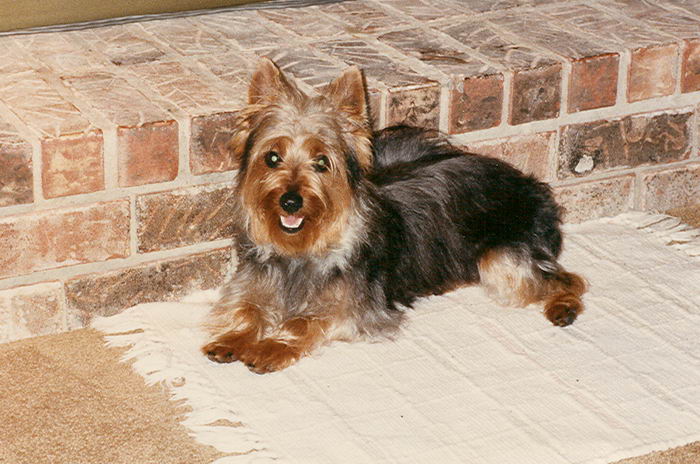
[0, 0, 700, 341]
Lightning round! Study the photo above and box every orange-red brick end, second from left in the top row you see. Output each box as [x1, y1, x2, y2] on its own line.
[41, 131, 105, 198]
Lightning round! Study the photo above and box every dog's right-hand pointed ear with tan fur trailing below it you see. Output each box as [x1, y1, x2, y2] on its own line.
[321, 66, 372, 172]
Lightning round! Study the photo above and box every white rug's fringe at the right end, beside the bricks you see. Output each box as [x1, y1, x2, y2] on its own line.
[602, 211, 700, 259]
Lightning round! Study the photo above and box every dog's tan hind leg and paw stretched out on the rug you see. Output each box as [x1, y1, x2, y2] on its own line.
[478, 248, 586, 327]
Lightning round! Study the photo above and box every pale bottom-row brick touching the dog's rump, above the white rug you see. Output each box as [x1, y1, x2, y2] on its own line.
[554, 175, 634, 222]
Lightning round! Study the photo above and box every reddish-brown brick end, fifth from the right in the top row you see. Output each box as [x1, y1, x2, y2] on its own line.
[448, 74, 503, 134]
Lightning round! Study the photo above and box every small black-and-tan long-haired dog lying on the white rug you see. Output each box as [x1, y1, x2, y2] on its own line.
[202, 58, 586, 374]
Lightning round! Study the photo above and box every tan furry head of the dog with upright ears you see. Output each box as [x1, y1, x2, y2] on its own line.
[232, 59, 371, 256]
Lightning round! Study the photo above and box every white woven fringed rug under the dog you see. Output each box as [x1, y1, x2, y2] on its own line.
[94, 213, 700, 464]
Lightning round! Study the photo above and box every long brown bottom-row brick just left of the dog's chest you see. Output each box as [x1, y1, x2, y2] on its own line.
[65, 248, 231, 325]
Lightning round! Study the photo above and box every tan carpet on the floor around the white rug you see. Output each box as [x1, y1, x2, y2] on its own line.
[0, 205, 700, 464]
